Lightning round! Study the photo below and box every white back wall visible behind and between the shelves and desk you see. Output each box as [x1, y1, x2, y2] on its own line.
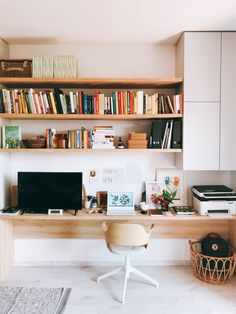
[5, 45, 230, 265]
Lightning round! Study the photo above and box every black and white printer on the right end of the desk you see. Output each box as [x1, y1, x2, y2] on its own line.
[191, 185, 236, 215]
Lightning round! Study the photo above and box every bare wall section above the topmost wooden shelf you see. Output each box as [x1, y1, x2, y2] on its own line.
[10, 44, 175, 77]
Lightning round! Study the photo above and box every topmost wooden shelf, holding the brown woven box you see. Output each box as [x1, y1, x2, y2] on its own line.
[0, 77, 183, 88]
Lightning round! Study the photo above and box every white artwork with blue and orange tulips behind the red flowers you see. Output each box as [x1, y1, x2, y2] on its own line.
[156, 169, 186, 205]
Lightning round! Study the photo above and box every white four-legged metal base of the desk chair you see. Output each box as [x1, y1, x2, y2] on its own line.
[97, 256, 159, 303]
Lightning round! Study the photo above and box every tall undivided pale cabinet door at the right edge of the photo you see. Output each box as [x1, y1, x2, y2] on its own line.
[220, 33, 236, 170]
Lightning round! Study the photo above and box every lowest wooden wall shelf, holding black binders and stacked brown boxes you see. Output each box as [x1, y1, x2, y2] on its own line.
[0, 148, 182, 154]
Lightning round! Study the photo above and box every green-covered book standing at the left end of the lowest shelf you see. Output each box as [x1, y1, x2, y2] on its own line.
[2, 125, 21, 148]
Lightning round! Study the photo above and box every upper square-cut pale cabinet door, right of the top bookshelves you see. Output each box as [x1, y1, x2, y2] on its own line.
[184, 32, 221, 101]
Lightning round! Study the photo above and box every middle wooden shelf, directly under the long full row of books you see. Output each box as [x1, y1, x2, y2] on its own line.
[0, 113, 183, 120]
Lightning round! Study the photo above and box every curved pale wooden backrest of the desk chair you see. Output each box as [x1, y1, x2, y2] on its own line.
[103, 223, 152, 246]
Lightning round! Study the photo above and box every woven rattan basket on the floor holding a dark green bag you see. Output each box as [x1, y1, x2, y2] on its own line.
[189, 240, 236, 285]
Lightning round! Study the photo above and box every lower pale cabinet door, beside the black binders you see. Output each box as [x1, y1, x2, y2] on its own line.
[183, 102, 220, 170]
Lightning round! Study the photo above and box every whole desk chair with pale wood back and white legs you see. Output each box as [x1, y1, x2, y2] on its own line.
[97, 222, 159, 303]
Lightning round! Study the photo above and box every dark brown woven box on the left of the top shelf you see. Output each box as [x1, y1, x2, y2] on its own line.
[0, 59, 32, 77]
